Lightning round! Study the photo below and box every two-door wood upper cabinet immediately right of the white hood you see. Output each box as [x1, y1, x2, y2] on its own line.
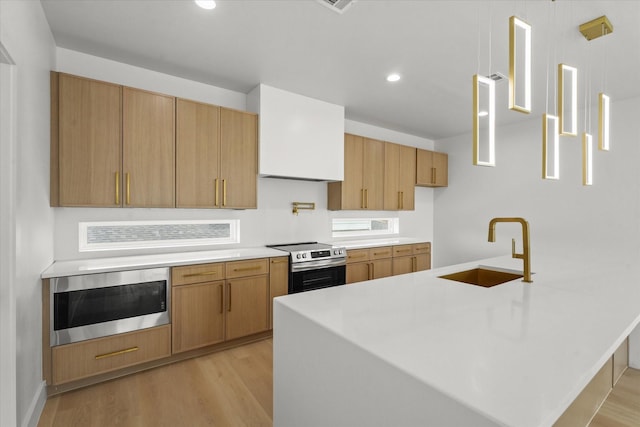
[328, 134, 385, 210]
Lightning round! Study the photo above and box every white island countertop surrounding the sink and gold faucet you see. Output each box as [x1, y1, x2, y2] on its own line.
[274, 252, 640, 427]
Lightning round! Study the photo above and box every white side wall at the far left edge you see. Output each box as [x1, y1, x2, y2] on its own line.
[0, 0, 55, 426]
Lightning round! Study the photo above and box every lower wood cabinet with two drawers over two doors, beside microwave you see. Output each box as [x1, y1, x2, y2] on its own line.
[171, 258, 270, 354]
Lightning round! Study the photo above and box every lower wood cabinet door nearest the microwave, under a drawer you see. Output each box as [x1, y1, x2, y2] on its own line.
[171, 280, 225, 353]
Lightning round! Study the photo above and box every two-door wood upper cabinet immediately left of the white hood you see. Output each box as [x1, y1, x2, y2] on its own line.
[176, 99, 258, 208]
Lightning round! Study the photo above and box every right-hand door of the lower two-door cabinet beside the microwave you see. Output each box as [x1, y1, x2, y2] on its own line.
[226, 275, 269, 340]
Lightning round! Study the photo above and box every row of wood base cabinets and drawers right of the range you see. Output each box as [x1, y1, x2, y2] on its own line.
[346, 242, 431, 284]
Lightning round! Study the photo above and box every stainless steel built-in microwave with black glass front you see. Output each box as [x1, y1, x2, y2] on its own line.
[49, 268, 171, 346]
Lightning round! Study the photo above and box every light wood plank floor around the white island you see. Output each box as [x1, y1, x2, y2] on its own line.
[38, 339, 640, 427]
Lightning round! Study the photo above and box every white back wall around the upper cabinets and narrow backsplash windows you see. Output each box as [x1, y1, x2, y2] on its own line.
[55, 48, 437, 260]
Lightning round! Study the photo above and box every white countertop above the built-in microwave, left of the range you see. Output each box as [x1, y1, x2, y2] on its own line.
[41, 247, 288, 279]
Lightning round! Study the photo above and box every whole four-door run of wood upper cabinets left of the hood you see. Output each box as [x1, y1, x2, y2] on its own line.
[51, 72, 258, 209]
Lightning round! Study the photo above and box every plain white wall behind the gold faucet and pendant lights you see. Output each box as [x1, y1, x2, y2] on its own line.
[434, 99, 640, 271]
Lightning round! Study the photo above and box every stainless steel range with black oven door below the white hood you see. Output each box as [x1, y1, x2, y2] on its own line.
[269, 242, 347, 294]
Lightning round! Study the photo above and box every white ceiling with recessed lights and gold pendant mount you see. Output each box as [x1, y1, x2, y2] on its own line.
[41, 0, 640, 139]
